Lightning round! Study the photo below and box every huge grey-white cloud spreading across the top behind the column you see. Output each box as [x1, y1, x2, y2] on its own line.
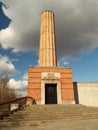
[0, 0, 98, 58]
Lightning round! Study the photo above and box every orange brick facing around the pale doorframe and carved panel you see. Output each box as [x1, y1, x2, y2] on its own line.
[28, 67, 74, 100]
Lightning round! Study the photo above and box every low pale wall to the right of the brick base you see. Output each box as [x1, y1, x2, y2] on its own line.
[74, 82, 98, 106]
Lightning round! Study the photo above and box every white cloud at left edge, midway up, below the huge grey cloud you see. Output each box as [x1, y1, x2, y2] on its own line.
[0, 55, 18, 76]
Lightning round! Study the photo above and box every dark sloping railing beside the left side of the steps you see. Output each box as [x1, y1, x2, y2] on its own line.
[0, 96, 36, 119]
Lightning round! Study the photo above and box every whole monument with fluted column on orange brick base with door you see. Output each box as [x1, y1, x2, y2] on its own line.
[28, 11, 75, 104]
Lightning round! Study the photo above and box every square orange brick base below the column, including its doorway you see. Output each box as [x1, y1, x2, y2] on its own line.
[28, 67, 75, 104]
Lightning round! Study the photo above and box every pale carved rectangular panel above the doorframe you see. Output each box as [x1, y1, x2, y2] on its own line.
[42, 72, 60, 79]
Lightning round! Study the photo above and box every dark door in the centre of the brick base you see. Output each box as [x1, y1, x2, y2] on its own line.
[45, 84, 57, 104]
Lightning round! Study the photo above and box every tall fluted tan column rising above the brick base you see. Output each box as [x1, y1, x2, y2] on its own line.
[39, 11, 57, 67]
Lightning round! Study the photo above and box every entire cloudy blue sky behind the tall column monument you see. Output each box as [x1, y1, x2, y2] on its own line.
[0, 0, 98, 95]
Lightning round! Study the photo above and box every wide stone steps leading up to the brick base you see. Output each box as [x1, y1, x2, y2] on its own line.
[0, 105, 98, 130]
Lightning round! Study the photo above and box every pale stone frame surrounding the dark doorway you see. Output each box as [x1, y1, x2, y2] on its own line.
[41, 79, 61, 104]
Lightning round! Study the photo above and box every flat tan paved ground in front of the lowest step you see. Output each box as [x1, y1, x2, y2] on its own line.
[0, 119, 98, 130]
